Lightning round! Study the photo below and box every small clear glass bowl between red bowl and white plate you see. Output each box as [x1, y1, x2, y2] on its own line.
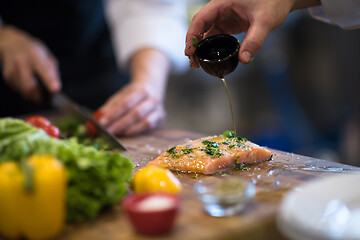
[194, 177, 255, 217]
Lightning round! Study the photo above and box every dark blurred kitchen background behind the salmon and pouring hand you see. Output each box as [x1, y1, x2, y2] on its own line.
[166, 0, 360, 166]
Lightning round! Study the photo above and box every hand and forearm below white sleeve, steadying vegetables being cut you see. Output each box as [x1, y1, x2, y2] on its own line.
[99, 48, 169, 136]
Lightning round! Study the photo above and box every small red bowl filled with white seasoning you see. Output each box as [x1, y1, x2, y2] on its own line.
[122, 193, 180, 236]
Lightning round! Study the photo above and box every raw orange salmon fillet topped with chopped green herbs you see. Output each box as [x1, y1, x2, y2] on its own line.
[148, 135, 272, 174]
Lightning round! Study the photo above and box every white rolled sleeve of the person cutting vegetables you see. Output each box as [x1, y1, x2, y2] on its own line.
[104, 0, 189, 72]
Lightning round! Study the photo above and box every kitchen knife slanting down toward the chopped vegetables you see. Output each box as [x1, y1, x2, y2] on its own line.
[50, 92, 126, 151]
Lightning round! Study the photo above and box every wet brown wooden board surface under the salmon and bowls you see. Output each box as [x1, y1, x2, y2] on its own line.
[58, 129, 360, 240]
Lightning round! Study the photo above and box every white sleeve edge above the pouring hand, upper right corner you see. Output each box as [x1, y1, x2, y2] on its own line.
[309, 0, 360, 29]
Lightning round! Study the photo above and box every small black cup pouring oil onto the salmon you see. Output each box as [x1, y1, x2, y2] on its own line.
[195, 34, 240, 78]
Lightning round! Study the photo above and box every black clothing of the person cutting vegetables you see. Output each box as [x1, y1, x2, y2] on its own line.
[0, 0, 128, 116]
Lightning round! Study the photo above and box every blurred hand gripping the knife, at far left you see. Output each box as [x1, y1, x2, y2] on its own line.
[0, 25, 61, 103]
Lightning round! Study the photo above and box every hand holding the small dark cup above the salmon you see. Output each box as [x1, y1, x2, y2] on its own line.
[185, 0, 321, 65]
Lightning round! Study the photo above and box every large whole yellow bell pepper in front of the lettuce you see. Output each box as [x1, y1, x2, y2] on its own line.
[0, 155, 66, 240]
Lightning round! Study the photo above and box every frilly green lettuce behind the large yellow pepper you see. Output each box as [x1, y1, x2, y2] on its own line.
[0, 118, 133, 221]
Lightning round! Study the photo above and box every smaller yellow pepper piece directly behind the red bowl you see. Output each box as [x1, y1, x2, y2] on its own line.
[132, 166, 182, 194]
